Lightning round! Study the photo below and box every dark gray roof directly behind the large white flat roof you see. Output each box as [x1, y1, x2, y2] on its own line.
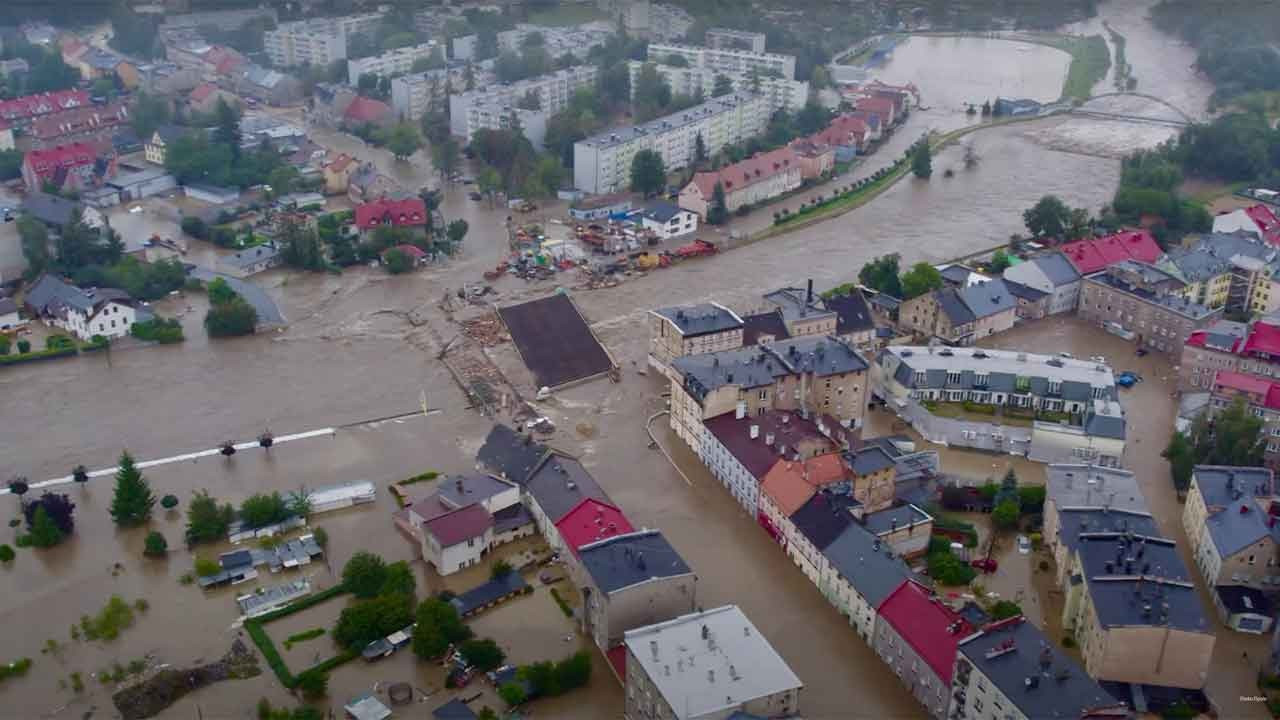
[577, 530, 692, 593]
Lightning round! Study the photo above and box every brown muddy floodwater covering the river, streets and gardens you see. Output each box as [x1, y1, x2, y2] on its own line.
[0, 4, 1262, 720]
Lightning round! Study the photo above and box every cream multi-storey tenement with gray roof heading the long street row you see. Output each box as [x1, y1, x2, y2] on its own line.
[671, 336, 868, 454]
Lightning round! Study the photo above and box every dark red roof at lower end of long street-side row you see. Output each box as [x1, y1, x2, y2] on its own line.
[878, 580, 973, 685]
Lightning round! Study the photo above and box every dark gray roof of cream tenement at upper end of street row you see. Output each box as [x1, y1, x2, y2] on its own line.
[672, 336, 867, 400]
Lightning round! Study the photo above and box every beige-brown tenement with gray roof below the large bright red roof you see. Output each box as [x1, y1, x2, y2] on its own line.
[1079, 260, 1222, 357]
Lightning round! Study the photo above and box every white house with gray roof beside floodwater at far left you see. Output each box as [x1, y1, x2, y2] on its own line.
[26, 274, 140, 340]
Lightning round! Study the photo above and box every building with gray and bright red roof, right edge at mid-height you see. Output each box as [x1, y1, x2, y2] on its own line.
[1178, 316, 1280, 392]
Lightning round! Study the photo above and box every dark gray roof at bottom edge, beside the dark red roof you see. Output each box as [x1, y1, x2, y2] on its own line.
[959, 618, 1116, 720]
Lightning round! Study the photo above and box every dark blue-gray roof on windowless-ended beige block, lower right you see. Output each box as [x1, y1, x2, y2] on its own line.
[1076, 534, 1210, 633]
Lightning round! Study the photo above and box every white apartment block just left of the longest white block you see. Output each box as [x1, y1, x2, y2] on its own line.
[450, 65, 599, 145]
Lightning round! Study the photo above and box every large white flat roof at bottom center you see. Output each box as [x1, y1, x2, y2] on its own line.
[623, 605, 804, 717]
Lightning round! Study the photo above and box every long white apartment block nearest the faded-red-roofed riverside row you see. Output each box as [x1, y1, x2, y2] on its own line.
[573, 92, 772, 193]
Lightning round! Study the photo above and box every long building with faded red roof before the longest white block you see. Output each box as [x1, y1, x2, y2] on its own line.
[680, 147, 804, 218]
